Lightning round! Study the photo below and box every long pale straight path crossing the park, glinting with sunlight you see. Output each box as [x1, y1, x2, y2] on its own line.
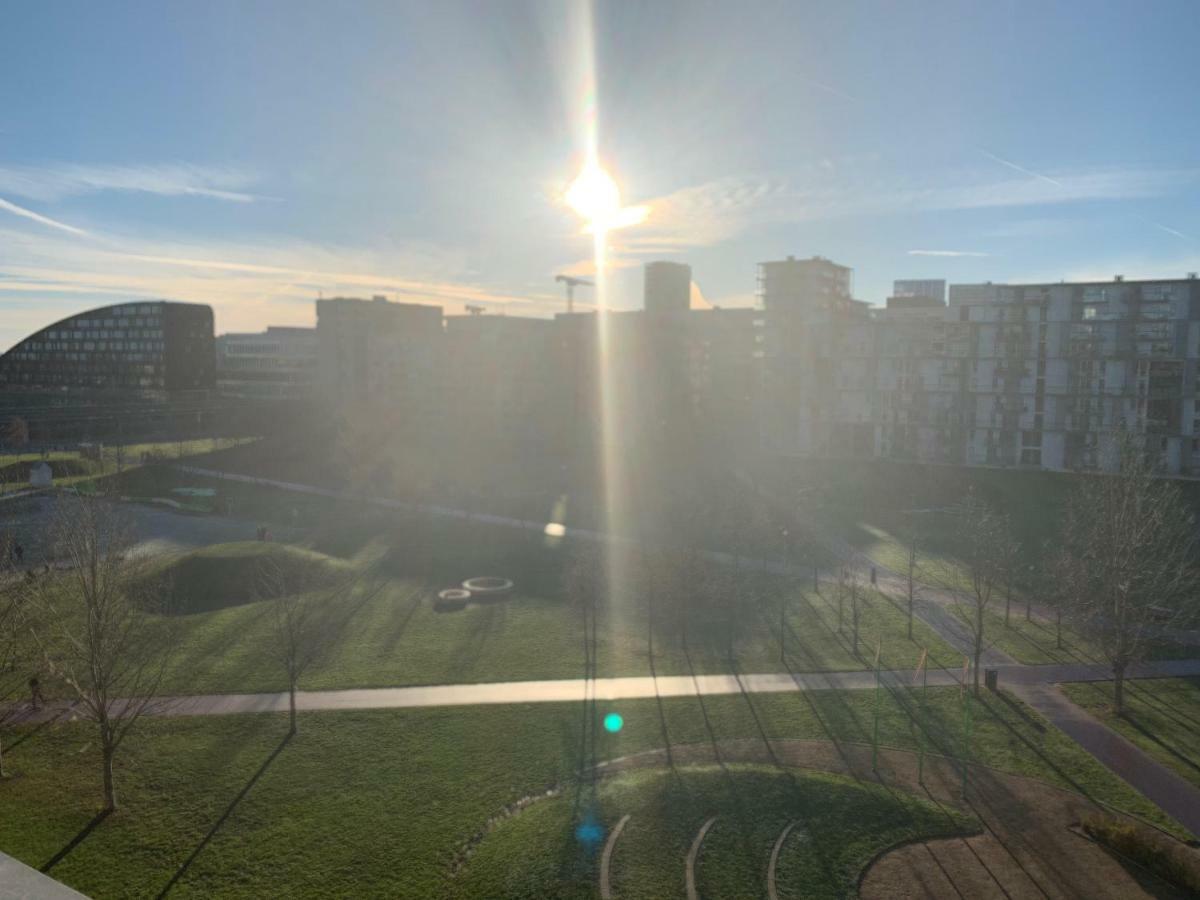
[14, 660, 1200, 721]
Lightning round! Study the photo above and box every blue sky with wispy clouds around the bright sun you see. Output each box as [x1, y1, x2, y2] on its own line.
[0, 0, 1200, 346]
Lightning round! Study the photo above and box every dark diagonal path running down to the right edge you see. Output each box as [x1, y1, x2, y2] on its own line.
[1013, 676, 1200, 835]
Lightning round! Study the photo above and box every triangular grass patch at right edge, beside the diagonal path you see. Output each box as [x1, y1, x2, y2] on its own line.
[1062, 678, 1200, 787]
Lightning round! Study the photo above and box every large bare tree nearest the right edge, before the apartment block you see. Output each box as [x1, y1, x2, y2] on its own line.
[1057, 436, 1198, 715]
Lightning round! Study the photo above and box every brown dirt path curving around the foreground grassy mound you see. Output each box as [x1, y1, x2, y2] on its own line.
[600, 740, 1200, 900]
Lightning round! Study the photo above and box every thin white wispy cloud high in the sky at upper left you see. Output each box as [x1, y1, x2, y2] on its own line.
[0, 163, 275, 203]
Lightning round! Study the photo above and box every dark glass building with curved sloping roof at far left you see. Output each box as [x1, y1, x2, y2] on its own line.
[0, 300, 216, 392]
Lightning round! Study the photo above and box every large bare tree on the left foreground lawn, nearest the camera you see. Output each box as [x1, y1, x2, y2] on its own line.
[24, 496, 176, 811]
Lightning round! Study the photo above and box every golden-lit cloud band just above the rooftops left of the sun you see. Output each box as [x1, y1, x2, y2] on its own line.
[0, 229, 562, 349]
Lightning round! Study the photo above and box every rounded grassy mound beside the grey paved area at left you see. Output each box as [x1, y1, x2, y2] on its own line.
[148, 541, 348, 613]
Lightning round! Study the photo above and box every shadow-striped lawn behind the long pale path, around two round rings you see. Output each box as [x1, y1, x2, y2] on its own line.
[136, 542, 958, 692]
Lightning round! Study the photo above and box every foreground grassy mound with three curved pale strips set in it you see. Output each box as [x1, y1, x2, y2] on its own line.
[455, 766, 978, 900]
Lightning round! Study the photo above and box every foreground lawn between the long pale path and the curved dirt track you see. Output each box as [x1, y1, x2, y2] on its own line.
[0, 689, 1180, 900]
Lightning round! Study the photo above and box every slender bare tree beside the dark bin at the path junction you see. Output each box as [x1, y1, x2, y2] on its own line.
[929, 492, 1014, 696]
